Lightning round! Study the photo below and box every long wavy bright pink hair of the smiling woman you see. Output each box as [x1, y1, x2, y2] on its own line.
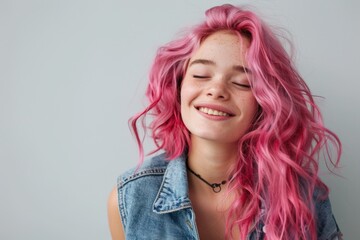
[130, 4, 341, 239]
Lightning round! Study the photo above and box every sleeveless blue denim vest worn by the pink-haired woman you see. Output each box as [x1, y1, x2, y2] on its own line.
[117, 154, 341, 240]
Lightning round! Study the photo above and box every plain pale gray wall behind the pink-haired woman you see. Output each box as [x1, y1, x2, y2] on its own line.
[0, 0, 360, 240]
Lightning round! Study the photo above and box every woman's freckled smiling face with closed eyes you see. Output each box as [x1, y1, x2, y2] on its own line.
[180, 31, 257, 143]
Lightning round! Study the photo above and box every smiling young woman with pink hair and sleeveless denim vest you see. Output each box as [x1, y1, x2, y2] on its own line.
[108, 5, 341, 240]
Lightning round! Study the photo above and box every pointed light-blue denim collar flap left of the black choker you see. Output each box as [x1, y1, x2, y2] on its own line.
[153, 154, 191, 214]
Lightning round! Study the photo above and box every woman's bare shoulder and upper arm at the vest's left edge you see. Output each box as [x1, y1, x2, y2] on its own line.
[107, 187, 125, 240]
